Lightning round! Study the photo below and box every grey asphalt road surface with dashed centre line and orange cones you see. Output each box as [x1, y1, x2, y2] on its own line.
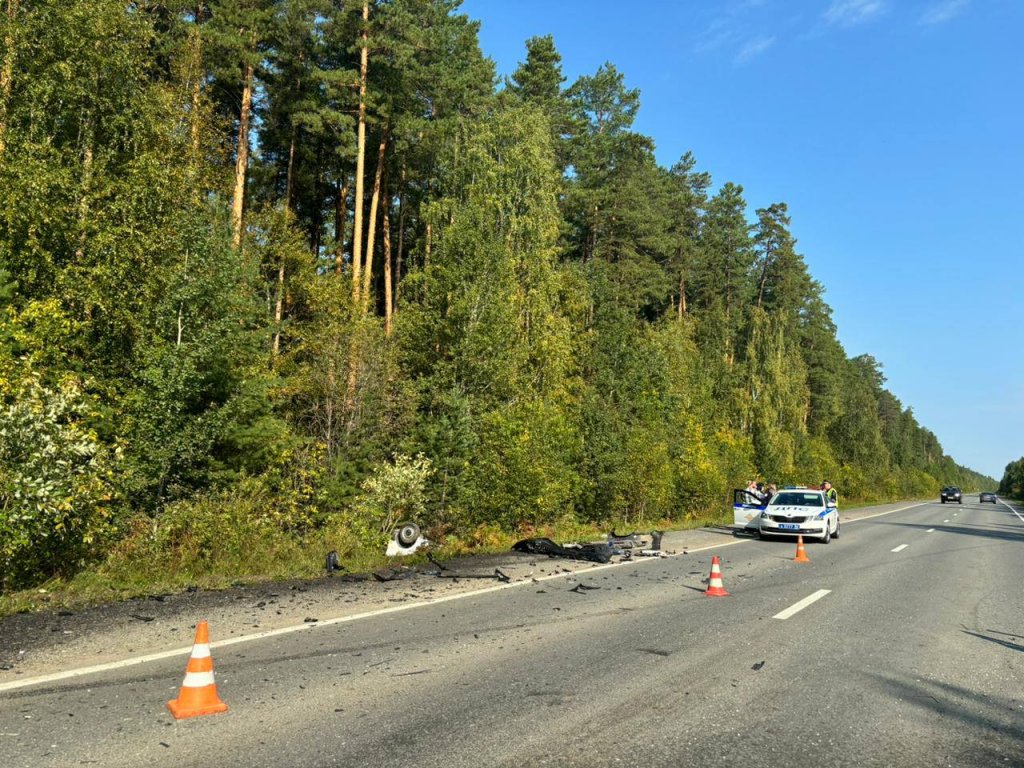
[0, 498, 1024, 768]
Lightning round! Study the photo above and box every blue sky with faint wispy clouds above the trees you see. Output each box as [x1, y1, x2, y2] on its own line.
[462, 0, 1024, 479]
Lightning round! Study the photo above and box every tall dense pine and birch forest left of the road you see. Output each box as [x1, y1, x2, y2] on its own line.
[0, 0, 994, 591]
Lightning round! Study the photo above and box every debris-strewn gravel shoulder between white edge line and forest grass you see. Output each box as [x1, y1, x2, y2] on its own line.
[0, 502, 913, 685]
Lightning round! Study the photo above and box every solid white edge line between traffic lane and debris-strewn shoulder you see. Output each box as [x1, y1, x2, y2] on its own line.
[0, 502, 933, 691]
